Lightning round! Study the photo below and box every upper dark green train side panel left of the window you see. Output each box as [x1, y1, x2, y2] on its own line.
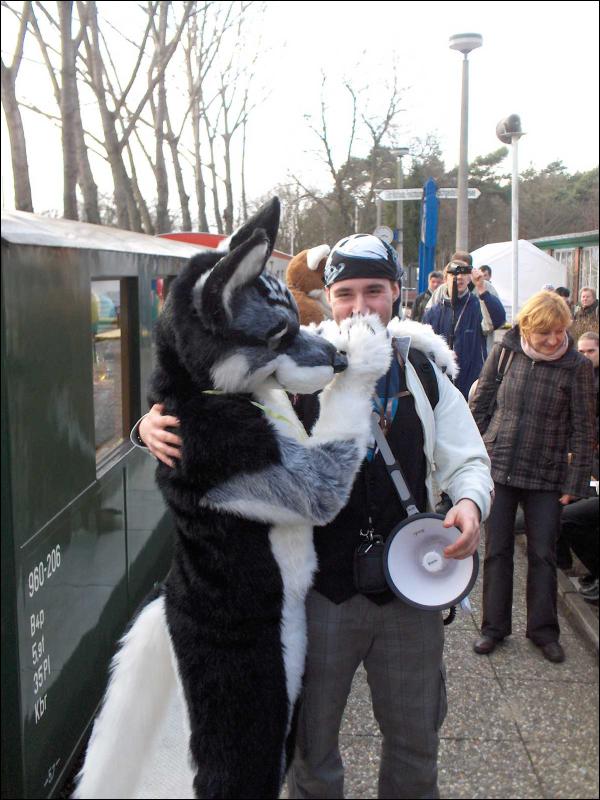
[2, 245, 96, 546]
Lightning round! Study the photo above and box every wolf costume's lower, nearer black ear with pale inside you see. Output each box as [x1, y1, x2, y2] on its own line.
[194, 228, 271, 324]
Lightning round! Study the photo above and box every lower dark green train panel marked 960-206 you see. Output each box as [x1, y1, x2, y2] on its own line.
[17, 469, 128, 798]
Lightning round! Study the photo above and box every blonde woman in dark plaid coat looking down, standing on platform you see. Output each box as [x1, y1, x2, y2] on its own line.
[471, 292, 594, 662]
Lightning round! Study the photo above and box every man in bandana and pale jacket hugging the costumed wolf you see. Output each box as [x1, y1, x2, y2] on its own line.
[139, 234, 492, 798]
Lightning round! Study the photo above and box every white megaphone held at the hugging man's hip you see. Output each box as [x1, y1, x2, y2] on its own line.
[383, 514, 479, 611]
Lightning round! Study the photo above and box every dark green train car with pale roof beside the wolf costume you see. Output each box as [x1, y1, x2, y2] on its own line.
[2, 212, 206, 798]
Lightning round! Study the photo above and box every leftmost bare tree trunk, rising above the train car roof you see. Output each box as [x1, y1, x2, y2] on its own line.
[2, 2, 33, 211]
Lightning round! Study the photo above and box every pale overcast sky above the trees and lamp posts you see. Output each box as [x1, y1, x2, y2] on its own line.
[2, 0, 599, 216]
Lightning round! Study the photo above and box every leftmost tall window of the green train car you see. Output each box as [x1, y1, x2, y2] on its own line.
[91, 280, 125, 462]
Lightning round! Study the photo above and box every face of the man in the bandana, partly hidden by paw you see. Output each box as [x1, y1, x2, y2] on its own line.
[327, 278, 400, 325]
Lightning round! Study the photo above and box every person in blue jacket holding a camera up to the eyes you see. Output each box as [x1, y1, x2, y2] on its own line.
[423, 260, 506, 399]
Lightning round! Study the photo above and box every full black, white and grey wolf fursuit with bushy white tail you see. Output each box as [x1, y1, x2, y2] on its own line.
[75, 198, 391, 798]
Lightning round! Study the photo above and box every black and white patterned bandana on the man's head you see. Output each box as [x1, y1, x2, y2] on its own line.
[323, 233, 404, 286]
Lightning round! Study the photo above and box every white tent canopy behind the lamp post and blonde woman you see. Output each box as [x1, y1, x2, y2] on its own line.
[471, 239, 567, 321]
